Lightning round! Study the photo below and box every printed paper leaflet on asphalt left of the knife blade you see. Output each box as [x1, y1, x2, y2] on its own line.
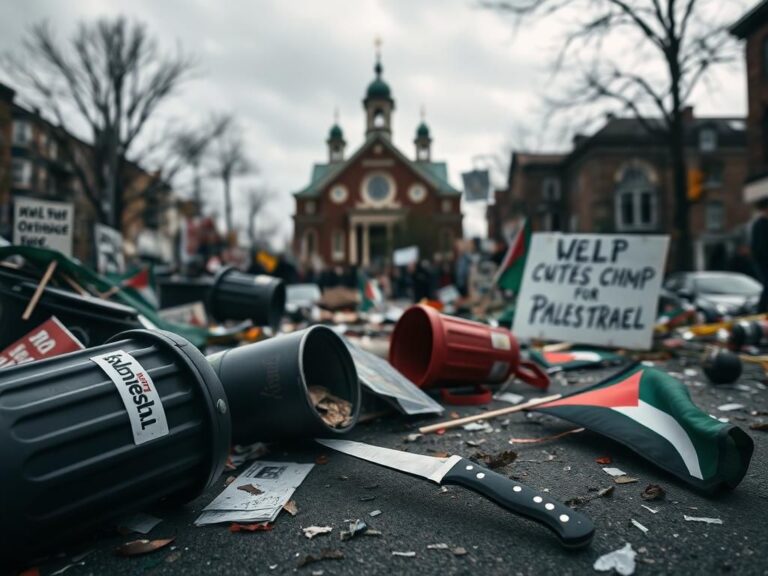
[195, 460, 314, 526]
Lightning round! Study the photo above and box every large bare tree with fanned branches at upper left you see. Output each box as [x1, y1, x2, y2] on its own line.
[7, 17, 194, 229]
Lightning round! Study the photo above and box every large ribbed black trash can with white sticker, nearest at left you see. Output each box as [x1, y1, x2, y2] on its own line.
[0, 330, 231, 563]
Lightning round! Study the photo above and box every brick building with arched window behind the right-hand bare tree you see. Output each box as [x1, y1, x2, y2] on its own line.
[489, 108, 750, 268]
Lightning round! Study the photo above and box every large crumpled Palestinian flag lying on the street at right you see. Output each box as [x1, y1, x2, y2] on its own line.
[534, 364, 754, 492]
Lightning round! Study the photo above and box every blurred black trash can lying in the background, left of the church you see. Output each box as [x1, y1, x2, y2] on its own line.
[206, 266, 285, 328]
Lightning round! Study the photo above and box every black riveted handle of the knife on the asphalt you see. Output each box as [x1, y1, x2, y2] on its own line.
[440, 458, 595, 548]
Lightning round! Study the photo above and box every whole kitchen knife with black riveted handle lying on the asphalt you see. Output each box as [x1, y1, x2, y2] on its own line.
[315, 438, 595, 548]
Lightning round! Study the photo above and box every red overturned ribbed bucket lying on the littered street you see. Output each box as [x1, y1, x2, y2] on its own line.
[389, 305, 549, 388]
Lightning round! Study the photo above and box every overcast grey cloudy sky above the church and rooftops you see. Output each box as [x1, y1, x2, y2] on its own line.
[0, 0, 746, 245]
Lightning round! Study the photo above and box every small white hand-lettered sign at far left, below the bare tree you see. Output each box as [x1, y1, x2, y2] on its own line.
[13, 196, 75, 256]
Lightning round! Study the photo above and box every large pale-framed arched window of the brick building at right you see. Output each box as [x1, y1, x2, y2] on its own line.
[614, 166, 658, 232]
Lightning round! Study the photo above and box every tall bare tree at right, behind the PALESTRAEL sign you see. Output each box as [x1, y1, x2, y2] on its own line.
[483, 0, 740, 269]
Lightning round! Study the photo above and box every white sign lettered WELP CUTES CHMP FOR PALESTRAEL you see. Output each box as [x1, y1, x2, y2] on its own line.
[514, 233, 669, 350]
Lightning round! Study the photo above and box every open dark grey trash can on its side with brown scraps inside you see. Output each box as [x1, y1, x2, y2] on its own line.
[208, 326, 360, 444]
